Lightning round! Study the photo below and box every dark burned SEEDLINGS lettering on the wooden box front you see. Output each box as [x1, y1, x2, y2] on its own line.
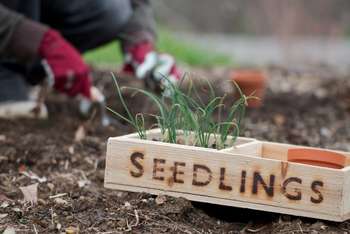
[129, 152, 324, 204]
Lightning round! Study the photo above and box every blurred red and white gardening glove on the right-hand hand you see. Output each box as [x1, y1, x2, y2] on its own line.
[123, 41, 181, 95]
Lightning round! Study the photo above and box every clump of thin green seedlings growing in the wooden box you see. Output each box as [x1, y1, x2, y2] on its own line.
[108, 75, 254, 149]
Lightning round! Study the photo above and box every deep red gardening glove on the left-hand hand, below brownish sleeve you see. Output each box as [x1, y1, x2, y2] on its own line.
[39, 29, 91, 99]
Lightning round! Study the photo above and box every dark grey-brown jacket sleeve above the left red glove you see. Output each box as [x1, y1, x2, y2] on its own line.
[0, 4, 47, 62]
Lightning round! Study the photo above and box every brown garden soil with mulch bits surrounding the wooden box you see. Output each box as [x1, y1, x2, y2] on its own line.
[0, 67, 350, 233]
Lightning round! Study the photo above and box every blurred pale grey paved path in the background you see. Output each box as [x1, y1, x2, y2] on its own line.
[178, 33, 350, 70]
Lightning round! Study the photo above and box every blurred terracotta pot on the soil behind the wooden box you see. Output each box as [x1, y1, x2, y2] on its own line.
[231, 70, 266, 108]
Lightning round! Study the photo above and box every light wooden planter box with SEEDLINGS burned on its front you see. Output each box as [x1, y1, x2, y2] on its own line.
[105, 129, 350, 221]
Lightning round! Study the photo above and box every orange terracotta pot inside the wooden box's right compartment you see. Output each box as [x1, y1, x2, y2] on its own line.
[288, 148, 346, 169]
